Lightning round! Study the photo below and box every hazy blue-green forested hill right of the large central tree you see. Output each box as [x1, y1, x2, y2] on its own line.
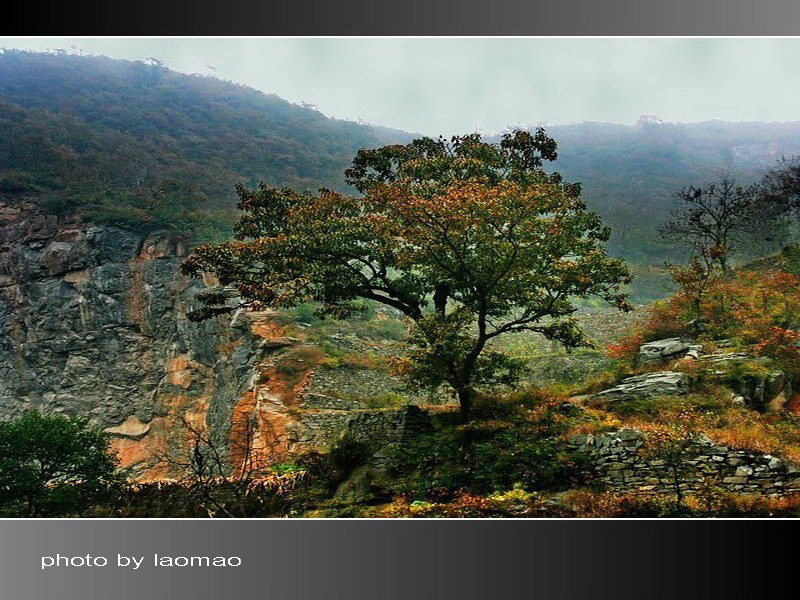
[548, 118, 800, 263]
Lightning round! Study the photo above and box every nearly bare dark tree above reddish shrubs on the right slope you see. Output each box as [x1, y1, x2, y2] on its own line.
[659, 177, 756, 275]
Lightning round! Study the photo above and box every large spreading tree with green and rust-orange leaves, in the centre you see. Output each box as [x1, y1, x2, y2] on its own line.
[183, 129, 630, 421]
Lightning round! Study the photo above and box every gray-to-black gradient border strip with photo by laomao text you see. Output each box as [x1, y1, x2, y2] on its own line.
[0, 520, 728, 600]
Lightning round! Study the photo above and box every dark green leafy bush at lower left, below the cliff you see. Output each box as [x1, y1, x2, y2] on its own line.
[0, 411, 121, 517]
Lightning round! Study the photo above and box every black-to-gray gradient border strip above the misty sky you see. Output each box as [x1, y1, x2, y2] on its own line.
[54, 0, 800, 35]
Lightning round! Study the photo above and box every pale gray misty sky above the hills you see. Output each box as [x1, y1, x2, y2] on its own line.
[0, 38, 800, 135]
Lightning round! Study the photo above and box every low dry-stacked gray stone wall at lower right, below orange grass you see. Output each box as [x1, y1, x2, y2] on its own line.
[569, 429, 800, 496]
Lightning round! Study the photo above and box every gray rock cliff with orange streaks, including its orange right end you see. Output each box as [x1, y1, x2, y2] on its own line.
[0, 201, 432, 479]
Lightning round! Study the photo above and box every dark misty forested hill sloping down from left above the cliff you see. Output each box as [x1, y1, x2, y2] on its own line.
[0, 50, 412, 237]
